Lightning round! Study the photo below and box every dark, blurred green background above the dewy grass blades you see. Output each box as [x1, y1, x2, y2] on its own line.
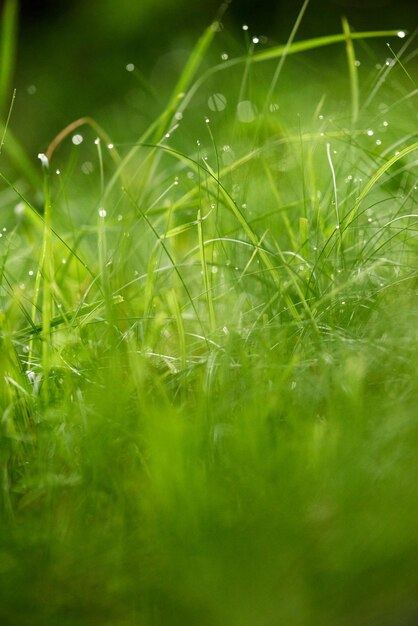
[6, 0, 418, 152]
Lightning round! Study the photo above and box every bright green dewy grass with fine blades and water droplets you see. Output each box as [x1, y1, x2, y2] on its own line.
[0, 2, 418, 626]
